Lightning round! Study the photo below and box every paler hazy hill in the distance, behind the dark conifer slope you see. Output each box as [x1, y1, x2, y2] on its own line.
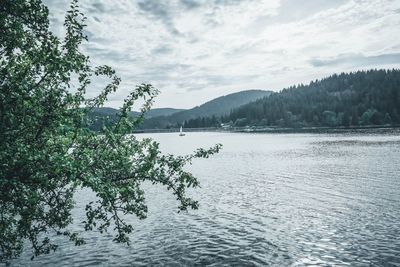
[141, 90, 271, 129]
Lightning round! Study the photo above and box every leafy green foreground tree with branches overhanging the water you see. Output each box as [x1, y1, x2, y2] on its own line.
[0, 0, 220, 261]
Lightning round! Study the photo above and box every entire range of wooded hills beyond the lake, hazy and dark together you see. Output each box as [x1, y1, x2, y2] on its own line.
[88, 70, 400, 129]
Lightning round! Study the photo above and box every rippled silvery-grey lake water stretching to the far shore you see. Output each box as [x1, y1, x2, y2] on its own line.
[12, 130, 400, 266]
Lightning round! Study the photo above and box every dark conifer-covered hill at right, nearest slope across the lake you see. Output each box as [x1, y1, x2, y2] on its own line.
[184, 70, 400, 128]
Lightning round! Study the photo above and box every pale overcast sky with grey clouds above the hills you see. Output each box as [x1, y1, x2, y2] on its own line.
[45, 0, 400, 108]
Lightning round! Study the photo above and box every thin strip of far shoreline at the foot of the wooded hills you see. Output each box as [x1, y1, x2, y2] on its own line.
[134, 125, 400, 134]
